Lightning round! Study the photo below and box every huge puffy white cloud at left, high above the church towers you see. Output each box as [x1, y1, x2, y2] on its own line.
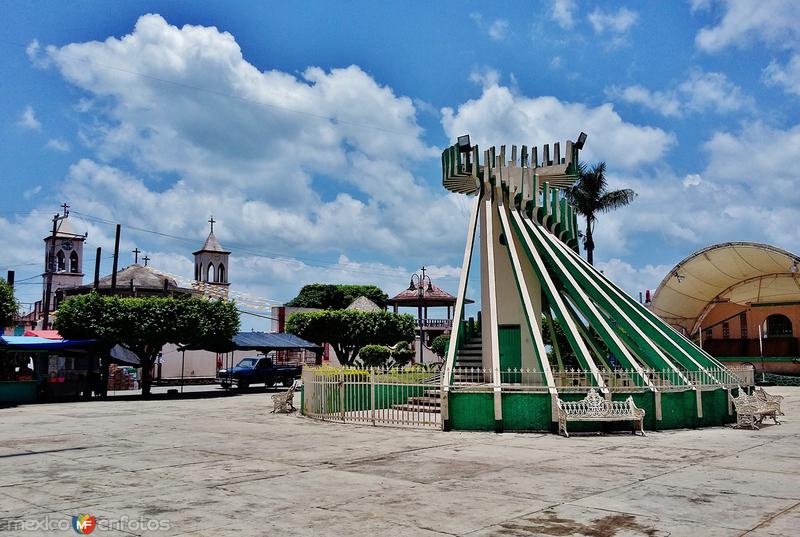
[29, 15, 468, 253]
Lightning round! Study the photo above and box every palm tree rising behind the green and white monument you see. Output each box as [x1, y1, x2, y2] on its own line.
[567, 162, 636, 265]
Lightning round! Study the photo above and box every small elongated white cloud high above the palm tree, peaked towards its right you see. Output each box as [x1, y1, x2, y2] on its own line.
[606, 70, 755, 117]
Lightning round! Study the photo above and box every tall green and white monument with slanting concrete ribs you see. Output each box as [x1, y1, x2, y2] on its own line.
[441, 133, 747, 430]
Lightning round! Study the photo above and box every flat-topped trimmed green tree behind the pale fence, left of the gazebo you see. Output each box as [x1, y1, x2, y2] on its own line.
[286, 310, 416, 365]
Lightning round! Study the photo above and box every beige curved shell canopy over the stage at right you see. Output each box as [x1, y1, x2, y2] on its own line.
[650, 242, 800, 334]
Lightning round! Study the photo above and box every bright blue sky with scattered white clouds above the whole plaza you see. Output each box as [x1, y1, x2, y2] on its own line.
[0, 0, 800, 326]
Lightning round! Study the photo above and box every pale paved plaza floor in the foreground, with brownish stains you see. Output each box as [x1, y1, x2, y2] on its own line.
[0, 388, 800, 537]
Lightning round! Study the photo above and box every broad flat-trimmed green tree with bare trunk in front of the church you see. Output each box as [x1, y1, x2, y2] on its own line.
[55, 293, 239, 396]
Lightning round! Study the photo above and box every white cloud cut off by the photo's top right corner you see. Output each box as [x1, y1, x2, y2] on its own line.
[692, 0, 800, 52]
